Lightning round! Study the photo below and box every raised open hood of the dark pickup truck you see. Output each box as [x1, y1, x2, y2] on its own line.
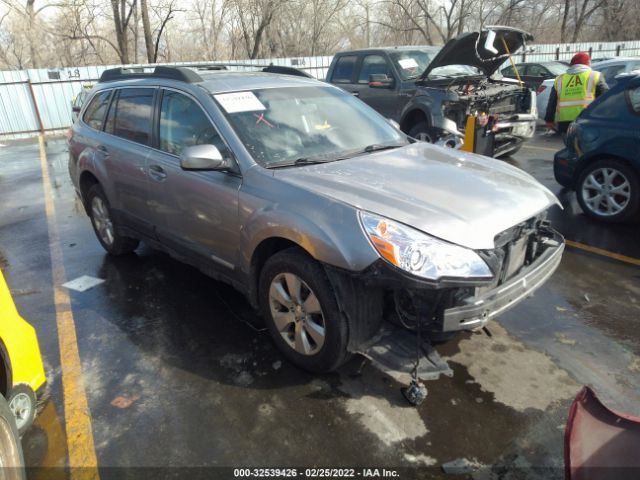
[421, 27, 533, 79]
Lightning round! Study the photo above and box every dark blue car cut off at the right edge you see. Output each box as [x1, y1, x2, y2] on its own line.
[553, 74, 640, 222]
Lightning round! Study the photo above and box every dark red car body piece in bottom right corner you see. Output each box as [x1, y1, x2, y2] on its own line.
[564, 386, 640, 480]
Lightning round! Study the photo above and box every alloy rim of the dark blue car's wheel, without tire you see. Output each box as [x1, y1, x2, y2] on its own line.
[582, 167, 631, 217]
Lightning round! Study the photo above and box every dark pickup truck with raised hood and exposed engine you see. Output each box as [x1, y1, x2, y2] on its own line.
[327, 27, 537, 157]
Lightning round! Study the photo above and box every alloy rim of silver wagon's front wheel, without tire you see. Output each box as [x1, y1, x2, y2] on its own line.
[269, 273, 326, 355]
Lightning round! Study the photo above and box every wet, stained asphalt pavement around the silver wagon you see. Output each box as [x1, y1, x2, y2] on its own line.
[0, 132, 640, 479]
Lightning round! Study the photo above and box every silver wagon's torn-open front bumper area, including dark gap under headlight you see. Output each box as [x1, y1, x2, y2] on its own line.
[330, 225, 564, 340]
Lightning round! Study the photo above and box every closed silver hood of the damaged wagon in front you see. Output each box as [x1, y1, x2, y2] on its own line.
[275, 142, 560, 249]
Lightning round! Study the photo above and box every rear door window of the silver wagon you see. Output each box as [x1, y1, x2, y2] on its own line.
[105, 88, 155, 145]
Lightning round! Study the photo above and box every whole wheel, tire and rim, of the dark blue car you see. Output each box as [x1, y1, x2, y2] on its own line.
[576, 159, 640, 222]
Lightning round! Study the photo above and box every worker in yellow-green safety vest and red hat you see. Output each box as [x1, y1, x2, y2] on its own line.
[544, 52, 609, 133]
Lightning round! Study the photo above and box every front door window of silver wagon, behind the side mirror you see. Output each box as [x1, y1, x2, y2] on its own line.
[159, 90, 226, 155]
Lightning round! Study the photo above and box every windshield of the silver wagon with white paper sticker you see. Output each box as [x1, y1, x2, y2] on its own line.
[213, 86, 408, 167]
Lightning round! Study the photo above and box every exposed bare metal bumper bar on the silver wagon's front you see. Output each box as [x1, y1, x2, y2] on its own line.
[442, 235, 564, 332]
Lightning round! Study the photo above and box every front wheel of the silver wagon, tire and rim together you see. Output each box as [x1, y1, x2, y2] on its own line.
[258, 248, 350, 372]
